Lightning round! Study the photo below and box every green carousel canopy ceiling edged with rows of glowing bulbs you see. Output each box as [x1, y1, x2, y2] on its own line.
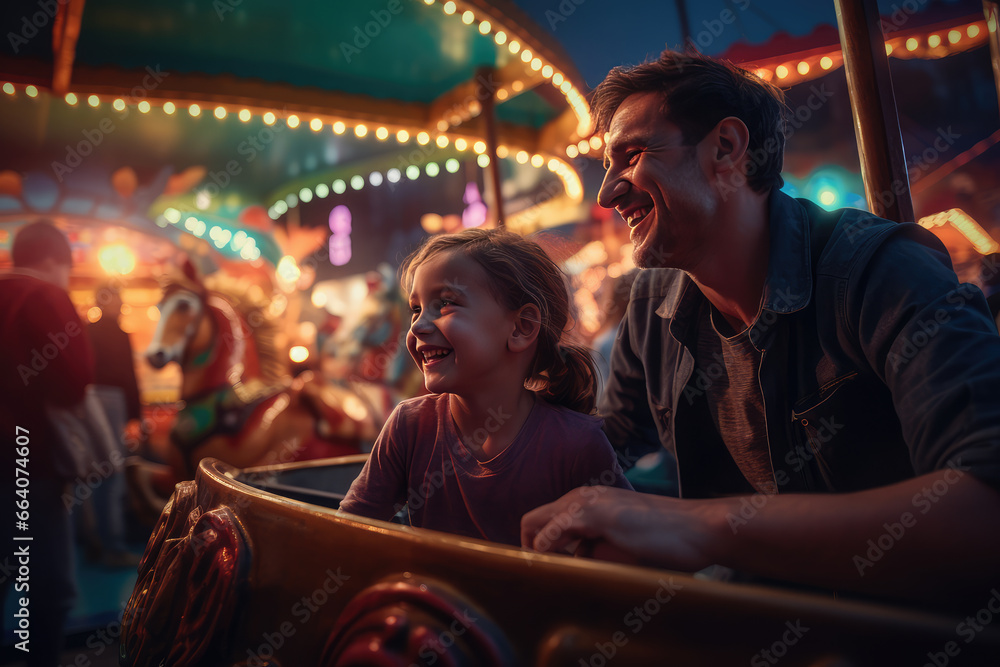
[0, 0, 590, 276]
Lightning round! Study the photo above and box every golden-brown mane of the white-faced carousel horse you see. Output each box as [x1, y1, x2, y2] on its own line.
[162, 272, 288, 382]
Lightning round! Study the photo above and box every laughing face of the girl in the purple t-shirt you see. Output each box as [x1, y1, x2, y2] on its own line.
[406, 250, 523, 396]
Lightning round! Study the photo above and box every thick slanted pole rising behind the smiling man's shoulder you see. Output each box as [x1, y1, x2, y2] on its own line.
[834, 0, 913, 222]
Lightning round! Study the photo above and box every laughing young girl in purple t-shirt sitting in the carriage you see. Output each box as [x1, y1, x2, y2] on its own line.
[340, 229, 631, 545]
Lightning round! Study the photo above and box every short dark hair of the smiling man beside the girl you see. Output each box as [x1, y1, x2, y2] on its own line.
[591, 50, 786, 193]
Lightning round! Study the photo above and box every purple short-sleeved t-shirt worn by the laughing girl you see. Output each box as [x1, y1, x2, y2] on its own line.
[340, 394, 632, 546]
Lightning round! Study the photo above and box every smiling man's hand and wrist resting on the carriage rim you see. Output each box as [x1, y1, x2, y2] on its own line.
[521, 486, 713, 572]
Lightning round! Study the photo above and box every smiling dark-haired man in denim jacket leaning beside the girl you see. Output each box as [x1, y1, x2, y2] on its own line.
[522, 52, 1000, 601]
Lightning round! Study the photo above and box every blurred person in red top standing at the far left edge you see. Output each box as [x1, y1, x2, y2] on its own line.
[0, 221, 94, 666]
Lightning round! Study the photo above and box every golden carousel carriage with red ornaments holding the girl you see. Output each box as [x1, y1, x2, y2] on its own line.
[120, 456, 1000, 667]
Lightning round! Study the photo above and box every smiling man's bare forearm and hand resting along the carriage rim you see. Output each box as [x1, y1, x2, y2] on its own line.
[521, 468, 1000, 600]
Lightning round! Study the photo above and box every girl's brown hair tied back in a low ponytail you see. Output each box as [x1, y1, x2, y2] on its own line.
[400, 229, 597, 414]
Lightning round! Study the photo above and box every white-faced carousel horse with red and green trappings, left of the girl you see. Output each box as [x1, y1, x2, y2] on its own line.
[139, 264, 382, 494]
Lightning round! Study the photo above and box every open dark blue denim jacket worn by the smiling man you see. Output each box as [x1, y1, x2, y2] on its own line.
[599, 192, 1000, 497]
